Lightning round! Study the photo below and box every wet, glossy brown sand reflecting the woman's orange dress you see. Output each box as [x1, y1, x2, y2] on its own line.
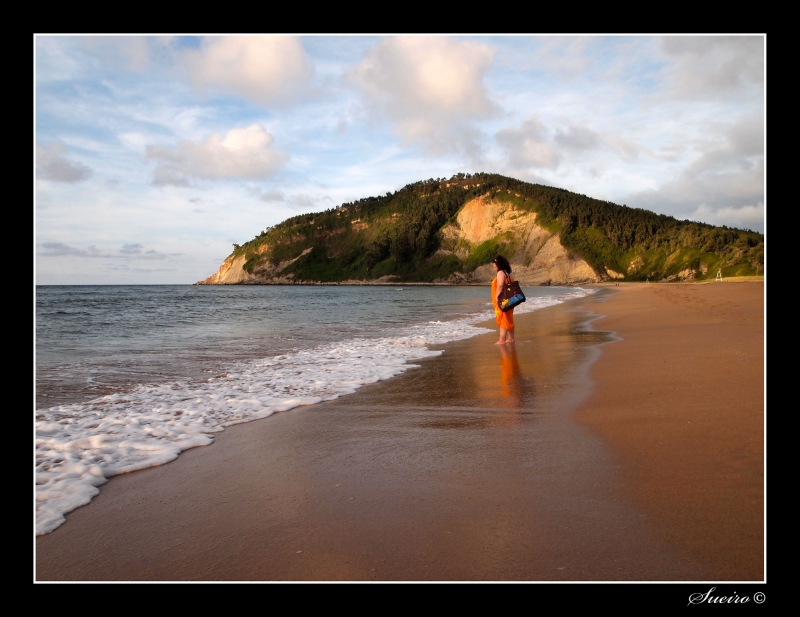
[36, 284, 764, 581]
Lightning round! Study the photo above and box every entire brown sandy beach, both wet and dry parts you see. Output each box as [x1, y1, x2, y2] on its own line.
[36, 282, 765, 581]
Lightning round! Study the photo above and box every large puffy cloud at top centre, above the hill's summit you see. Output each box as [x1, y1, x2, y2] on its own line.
[346, 37, 497, 153]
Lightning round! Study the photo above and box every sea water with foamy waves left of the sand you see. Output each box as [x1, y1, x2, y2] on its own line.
[35, 285, 591, 534]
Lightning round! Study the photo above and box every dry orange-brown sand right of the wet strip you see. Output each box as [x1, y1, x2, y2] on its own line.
[577, 282, 765, 581]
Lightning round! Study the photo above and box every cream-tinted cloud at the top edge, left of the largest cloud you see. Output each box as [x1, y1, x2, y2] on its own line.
[183, 36, 313, 105]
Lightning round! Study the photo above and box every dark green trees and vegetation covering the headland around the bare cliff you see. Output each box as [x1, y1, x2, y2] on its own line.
[225, 173, 764, 282]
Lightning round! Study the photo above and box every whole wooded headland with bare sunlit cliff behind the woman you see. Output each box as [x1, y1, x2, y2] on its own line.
[198, 173, 764, 285]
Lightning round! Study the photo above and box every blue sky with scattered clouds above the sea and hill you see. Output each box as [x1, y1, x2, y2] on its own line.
[34, 35, 766, 285]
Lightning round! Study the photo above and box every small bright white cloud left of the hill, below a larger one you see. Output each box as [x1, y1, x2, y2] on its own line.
[146, 124, 288, 186]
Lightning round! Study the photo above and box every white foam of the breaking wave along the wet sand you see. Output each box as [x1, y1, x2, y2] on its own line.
[36, 288, 591, 534]
